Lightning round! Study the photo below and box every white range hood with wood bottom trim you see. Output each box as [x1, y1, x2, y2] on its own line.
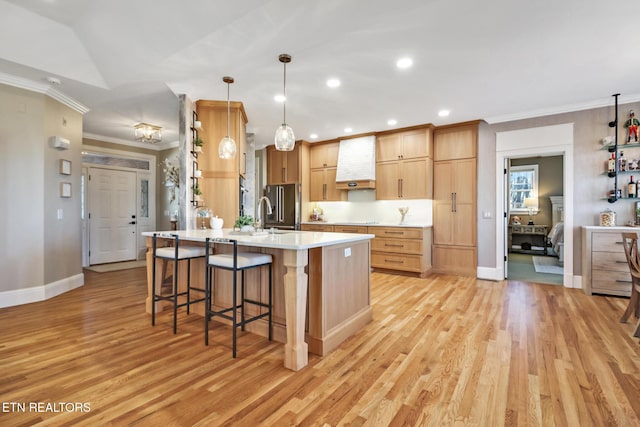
[336, 135, 376, 190]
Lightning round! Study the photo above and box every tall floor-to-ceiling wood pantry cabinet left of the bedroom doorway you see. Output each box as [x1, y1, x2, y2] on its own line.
[433, 123, 478, 276]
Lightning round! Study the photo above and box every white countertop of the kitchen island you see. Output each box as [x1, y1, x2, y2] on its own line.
[142, 228, 375, 250]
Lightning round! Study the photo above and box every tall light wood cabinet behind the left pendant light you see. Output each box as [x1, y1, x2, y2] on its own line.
[196, 100, 247, 224]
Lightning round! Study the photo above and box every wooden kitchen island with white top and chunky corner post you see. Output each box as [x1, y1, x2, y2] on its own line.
[143, 229, 374, 371]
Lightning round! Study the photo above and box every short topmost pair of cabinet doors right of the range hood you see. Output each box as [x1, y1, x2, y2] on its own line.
[376, 126, 433, 162]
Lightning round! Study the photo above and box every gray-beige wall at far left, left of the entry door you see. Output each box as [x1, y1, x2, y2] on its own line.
[0, 84, 82, 292]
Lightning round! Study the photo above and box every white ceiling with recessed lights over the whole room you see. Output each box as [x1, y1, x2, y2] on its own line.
[0, 0, 640, 148]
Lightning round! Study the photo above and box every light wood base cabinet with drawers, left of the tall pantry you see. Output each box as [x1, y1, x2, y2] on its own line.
[368, 227, 431, 277]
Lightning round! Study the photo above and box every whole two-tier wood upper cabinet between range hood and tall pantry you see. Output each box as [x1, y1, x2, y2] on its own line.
[376, 125, 433, 200]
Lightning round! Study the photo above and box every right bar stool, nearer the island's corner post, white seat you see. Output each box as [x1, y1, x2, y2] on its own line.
[204, 238, 273, 359]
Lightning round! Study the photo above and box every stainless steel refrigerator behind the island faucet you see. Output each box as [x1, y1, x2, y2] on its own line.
[262, 184, 301, 230]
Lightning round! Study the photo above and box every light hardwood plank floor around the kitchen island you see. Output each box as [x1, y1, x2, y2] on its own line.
[0, 268, 640, 426]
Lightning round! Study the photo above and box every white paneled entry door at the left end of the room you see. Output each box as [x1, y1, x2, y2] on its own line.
[89, 168, 137, 265]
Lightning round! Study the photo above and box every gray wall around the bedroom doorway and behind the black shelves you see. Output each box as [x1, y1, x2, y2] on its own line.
[478, 98, 640, 275]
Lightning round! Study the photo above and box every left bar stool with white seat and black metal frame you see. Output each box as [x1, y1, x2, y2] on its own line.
[151, 233, 206, 334]
